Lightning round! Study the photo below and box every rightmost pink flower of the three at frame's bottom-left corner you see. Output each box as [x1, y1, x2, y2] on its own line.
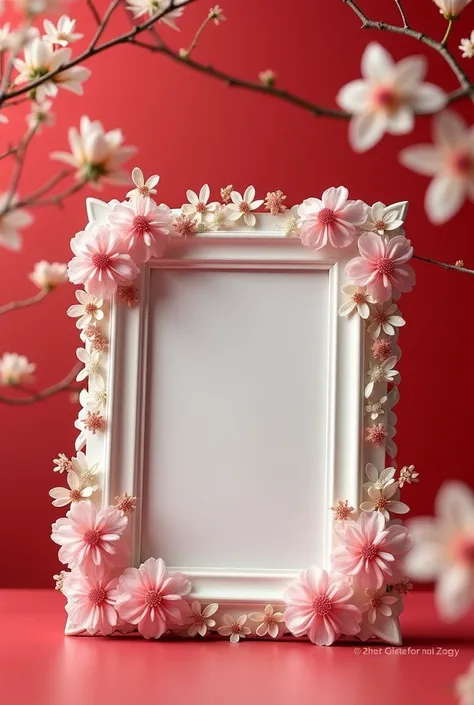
[117, 558, 191, 639]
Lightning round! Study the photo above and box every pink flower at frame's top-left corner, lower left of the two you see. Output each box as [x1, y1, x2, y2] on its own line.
[68, 223, 139, 299]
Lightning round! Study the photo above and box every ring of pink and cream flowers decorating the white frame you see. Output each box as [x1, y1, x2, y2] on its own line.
[50, 168, 418, 645]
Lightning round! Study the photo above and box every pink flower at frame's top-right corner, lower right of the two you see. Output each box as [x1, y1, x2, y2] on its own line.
[346, 233, 415, 303]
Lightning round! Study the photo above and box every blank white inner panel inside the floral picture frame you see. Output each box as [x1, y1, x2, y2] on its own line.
[140, 265, 330, 571]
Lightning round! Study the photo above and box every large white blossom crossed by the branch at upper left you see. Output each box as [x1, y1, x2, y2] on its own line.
[13, 38, 91, 102]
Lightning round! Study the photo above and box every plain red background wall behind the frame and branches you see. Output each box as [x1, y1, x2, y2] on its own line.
[0, 0, 474, 587]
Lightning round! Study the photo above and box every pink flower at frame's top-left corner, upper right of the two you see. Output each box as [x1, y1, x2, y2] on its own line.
[109, 198, 173, 263]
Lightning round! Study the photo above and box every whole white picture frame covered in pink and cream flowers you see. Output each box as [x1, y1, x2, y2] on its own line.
[50, 176, 417, 645]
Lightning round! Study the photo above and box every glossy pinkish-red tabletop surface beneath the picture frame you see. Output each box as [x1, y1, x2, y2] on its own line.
[0, 590, 474, 705]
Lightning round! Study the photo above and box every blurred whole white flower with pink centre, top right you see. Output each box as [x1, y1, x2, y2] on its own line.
[337, 42, 446, 152]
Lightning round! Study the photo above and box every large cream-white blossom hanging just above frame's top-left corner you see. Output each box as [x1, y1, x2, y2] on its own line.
[51, 115, 136, 188]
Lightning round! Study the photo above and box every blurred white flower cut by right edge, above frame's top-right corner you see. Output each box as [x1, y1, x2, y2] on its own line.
[400, 110, 474, 224]
